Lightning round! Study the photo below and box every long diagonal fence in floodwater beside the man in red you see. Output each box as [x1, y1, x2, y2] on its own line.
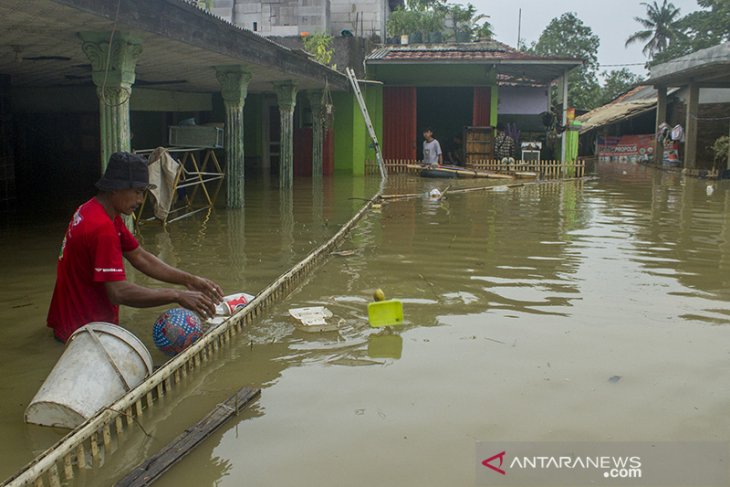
[0, 192, 381, 487]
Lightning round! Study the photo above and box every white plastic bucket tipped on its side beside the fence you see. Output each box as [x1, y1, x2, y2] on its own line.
[25, 322, 152, 429]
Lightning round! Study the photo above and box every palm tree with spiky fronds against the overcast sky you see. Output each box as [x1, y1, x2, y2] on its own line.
[626, 0, 684, 58]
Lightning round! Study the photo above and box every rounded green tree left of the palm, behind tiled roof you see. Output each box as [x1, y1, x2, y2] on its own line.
[528, 12, 601, 110]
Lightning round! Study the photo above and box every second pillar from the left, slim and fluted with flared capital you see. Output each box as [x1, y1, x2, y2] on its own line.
[215, 65, 251, 208]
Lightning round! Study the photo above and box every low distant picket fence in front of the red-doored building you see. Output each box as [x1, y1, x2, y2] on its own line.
[365, 159, 586, 179]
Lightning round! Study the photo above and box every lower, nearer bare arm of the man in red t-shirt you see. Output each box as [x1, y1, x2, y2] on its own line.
[104, 281, 215, 317]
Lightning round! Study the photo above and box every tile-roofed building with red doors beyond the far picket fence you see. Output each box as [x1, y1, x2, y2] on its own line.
[365, 41, 582, 160]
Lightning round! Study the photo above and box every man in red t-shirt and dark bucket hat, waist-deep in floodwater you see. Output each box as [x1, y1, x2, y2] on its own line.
[48, 152, 223, 342]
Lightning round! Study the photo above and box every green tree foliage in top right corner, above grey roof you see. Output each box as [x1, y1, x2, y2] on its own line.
[650, 0, 730, 64]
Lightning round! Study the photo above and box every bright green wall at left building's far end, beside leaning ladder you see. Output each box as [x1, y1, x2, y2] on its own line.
[332, 91, 367, 176]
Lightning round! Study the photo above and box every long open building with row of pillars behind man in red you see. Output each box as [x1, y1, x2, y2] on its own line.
[0, 0, 379, 217]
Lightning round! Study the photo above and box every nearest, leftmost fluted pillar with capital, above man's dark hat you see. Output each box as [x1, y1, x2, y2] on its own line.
[80, 32, 142, 171]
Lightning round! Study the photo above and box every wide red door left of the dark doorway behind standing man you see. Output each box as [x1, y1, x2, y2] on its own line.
[383, 86, 418, 161]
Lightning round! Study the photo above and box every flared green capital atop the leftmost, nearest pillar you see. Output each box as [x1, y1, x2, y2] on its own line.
[79, 32, 142, 90]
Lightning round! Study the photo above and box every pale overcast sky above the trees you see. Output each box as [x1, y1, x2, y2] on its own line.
[472, 0, 699, 75]
